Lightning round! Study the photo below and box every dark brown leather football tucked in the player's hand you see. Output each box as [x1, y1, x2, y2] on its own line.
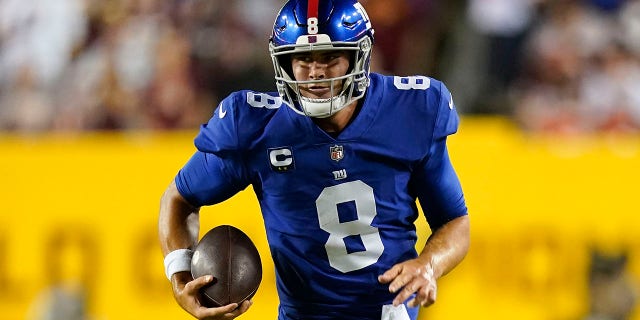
[191, 225, 262, 307]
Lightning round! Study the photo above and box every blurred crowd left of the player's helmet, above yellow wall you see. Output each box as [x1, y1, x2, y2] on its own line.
[0, 0, 280, 131]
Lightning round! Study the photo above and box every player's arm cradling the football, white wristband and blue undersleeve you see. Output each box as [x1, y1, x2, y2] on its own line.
[158, 152, 251, 319]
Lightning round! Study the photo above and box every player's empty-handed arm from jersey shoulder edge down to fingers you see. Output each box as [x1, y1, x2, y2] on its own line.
[379, 85, 469, 306]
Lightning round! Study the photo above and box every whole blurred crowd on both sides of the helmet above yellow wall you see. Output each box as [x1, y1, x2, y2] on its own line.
[0, 0, 640, 133]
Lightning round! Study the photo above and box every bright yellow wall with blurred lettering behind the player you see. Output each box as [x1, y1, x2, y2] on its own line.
[0, 118, 640, 320]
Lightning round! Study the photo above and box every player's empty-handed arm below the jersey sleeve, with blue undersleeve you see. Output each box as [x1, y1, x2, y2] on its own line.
[379, 152, 469, 307]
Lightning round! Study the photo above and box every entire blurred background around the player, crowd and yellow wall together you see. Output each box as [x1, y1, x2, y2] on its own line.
[0, 0, 640, 320]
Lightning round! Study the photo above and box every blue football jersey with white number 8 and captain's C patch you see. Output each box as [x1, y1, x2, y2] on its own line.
[176, 73, 467, 319]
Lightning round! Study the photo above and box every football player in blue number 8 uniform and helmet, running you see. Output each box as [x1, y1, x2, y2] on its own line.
[159, 0, 469, 320]
